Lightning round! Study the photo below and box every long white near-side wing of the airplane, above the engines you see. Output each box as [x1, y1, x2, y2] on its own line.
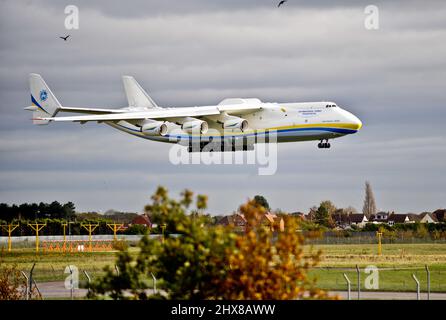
[36, 105, 261, 123]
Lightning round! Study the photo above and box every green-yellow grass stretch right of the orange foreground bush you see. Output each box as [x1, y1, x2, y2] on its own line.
[311, 243, 446, 292]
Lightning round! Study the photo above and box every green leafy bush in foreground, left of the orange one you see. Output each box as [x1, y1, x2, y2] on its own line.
[91, 187, 235, 299]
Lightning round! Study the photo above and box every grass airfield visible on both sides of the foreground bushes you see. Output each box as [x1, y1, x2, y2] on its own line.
[0, 243, 446, 292]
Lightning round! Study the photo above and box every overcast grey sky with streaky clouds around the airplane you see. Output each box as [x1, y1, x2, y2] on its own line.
[0, 0, 446, 214]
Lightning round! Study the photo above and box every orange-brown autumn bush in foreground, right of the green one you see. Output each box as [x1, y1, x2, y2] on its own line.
[221, 200, 327, 300]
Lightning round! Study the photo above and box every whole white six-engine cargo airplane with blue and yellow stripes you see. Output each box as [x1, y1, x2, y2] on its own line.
[25, 73, 362, 152]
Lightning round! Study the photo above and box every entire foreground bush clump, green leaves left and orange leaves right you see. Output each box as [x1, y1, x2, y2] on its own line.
[89, 187, 332, 299]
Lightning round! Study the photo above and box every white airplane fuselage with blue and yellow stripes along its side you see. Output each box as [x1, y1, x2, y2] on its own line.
[107, 102, 362, 143]
